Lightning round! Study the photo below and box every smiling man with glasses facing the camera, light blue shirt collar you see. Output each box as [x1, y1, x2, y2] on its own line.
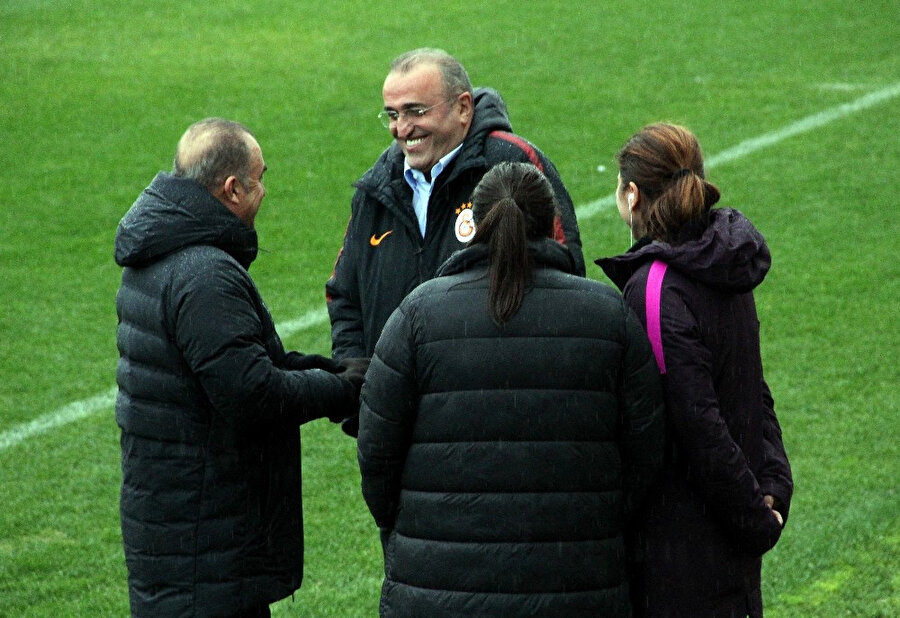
[325, 48, 585, 435]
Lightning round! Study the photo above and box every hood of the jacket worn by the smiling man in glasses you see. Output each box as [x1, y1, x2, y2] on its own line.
[354, 88, 512, 197]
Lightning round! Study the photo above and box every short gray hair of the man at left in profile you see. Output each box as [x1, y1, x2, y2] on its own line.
[172, 118, 253, 191]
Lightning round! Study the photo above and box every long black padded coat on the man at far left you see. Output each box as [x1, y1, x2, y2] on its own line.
[115, 173, 353, 618]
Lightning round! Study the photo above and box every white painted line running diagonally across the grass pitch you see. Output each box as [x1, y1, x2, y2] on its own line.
[0, 83, 900, 451]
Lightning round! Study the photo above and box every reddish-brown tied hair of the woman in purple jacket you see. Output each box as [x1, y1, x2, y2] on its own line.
[616, 123, 719, 242]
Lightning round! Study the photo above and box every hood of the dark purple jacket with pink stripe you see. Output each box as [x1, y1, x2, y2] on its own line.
[595, 208, 772, 292]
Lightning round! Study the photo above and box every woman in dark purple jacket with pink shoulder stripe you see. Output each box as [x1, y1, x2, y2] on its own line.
[597, 124, 793, 617]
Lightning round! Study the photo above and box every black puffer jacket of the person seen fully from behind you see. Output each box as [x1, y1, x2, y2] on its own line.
[358, 240, 663, 617]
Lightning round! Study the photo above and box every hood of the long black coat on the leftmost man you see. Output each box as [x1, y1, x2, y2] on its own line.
[115, 172, 258, 268]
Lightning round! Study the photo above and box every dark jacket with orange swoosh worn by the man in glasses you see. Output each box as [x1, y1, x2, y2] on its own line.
[325, 88, 584, 358]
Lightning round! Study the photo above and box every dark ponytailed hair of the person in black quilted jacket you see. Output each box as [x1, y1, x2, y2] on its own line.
[472, 162, 556, 324]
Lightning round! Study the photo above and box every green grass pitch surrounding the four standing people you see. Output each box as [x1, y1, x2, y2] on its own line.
[0, 0, 900, 618]
